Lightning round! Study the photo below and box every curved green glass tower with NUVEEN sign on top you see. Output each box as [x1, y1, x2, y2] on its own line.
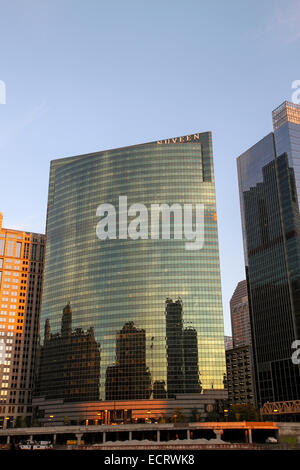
[37, 132, 225, 412]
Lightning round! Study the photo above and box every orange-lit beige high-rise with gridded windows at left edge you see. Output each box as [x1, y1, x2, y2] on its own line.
[0, 212, 45, 428]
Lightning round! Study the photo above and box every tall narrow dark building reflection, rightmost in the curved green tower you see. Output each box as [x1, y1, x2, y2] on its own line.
[166, 299, 201, 398]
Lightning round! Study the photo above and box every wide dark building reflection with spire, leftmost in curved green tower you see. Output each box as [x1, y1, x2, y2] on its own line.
[37, 304, 100, 401]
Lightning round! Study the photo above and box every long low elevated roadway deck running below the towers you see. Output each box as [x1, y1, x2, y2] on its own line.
[0, 421, 280, 445]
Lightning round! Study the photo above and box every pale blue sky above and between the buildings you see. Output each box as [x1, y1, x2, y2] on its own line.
[0, 0, 300, 334]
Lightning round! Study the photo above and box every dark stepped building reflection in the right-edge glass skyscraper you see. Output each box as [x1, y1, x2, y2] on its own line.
[243, 154, 300, 405]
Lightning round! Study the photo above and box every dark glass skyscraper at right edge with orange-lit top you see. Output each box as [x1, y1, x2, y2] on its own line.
[237, 102, 300, 405]
